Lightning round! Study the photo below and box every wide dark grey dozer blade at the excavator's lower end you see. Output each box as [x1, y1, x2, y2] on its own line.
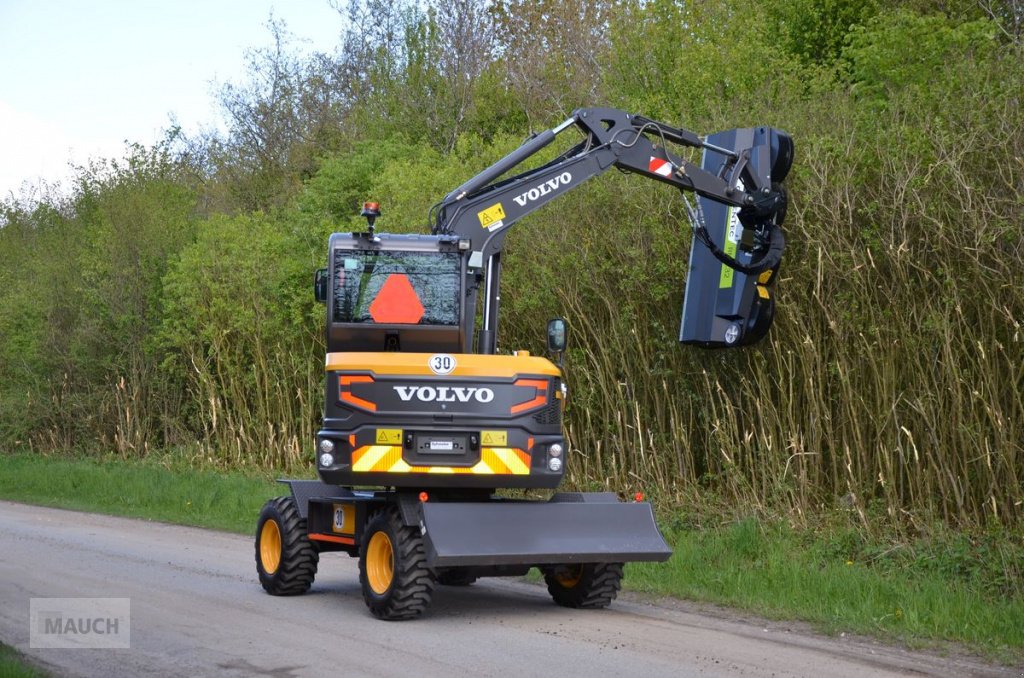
[423, 500, 672, 567]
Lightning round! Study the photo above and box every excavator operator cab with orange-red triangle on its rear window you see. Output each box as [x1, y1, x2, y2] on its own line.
[315, 231, 466, 353]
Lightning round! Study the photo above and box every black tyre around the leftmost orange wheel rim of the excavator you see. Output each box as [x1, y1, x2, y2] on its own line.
[256, 497, 319, 596]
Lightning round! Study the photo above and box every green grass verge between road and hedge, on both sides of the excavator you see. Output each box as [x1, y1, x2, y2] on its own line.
[0, 454, 1024, 661]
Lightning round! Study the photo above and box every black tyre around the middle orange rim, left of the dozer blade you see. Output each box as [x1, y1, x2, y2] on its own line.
[359, 507, 437, 621]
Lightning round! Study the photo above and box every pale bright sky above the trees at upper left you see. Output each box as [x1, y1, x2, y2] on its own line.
[0, 0, 343, 200]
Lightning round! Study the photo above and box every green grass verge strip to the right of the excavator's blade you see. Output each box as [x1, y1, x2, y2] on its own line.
[627, 519, 1024, 661]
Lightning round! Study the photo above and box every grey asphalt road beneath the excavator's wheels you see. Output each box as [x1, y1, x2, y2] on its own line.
[0, 502, 1020, 678]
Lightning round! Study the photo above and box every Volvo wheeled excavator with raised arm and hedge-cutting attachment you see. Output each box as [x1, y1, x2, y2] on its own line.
[256, 109, 793, 620]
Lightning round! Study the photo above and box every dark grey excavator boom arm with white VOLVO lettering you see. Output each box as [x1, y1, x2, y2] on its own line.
[431, 108, 793, 353]
